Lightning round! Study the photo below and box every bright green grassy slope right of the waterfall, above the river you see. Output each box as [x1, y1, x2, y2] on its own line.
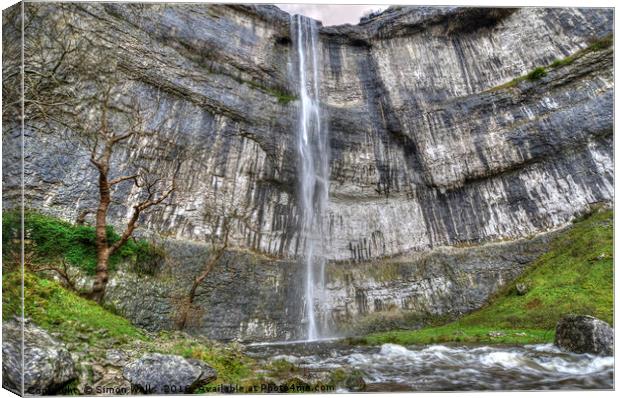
[360, 210, 613, 344]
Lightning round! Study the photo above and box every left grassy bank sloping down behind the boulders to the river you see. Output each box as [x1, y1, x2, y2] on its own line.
[2, 272, 255, 385]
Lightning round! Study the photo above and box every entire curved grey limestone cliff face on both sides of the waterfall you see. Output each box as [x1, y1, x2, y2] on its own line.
[3, 3, 614, 339]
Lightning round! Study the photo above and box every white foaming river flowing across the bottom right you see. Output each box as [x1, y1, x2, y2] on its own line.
[248, 342, 614, 392]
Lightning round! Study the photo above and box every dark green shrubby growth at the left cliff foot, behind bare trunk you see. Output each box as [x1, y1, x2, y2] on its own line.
[2, 211, 164, 275]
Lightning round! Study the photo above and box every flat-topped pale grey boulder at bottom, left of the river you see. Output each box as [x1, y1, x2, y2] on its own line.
[123, 353, 217, 394]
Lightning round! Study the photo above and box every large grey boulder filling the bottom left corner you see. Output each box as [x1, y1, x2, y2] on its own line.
[2, 320, 76, 395]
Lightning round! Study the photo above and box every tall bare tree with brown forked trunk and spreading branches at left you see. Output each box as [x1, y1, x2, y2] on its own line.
[17, 5, 182, 302]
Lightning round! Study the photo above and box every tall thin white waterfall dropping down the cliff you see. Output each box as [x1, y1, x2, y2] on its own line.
[291, 15, 329, 340]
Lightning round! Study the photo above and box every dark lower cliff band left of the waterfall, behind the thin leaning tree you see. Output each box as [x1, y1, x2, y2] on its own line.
[105, 241, 303, 341]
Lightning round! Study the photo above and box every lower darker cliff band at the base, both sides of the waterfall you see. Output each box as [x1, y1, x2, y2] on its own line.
[106, 234, 554, 341]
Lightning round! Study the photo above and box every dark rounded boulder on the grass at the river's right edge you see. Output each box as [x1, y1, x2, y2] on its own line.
[555, 315, 614, 356]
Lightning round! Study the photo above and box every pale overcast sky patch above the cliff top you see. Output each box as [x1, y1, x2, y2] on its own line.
[276, 4, 387, 26]
